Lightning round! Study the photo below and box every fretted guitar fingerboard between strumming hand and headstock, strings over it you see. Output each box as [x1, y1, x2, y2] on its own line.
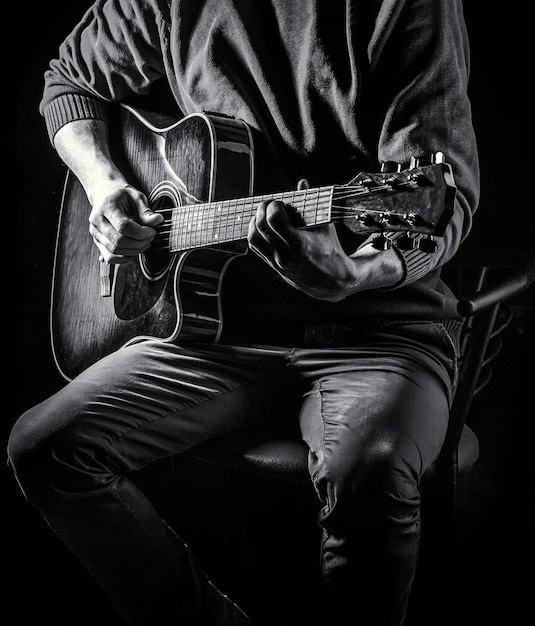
[166, 186, 334, 252]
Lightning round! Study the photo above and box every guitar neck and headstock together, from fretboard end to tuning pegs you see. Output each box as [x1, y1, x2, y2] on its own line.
[153, 163, 455, 252]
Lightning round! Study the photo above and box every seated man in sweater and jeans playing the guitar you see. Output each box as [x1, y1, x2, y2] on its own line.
[9, 0, 478, 626]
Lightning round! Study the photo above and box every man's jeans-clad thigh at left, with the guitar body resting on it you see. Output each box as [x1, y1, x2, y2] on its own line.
[12, 341, 284, 471]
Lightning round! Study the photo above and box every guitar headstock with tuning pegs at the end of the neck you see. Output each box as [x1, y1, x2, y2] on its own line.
[340, 153, 456, 241]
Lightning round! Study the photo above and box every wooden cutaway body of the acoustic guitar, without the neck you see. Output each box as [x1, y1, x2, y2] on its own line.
[51, 106, 253, 380]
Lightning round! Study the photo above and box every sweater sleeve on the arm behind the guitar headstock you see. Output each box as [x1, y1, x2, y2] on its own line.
[365, 0, 479, 288]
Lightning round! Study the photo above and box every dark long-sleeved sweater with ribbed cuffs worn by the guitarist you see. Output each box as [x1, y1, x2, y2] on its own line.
[41, 0, 479, 332]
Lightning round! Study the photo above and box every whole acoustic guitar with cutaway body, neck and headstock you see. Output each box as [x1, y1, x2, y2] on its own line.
[50, 105, 455, 380]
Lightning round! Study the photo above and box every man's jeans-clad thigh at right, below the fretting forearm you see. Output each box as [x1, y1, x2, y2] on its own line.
[300, 350, 449, 487]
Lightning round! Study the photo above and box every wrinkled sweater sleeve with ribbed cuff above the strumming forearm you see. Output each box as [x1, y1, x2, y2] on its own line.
[39, 0, 167, 140]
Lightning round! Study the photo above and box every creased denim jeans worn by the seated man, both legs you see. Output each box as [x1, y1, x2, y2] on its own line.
[8, 322, 456, 626]
